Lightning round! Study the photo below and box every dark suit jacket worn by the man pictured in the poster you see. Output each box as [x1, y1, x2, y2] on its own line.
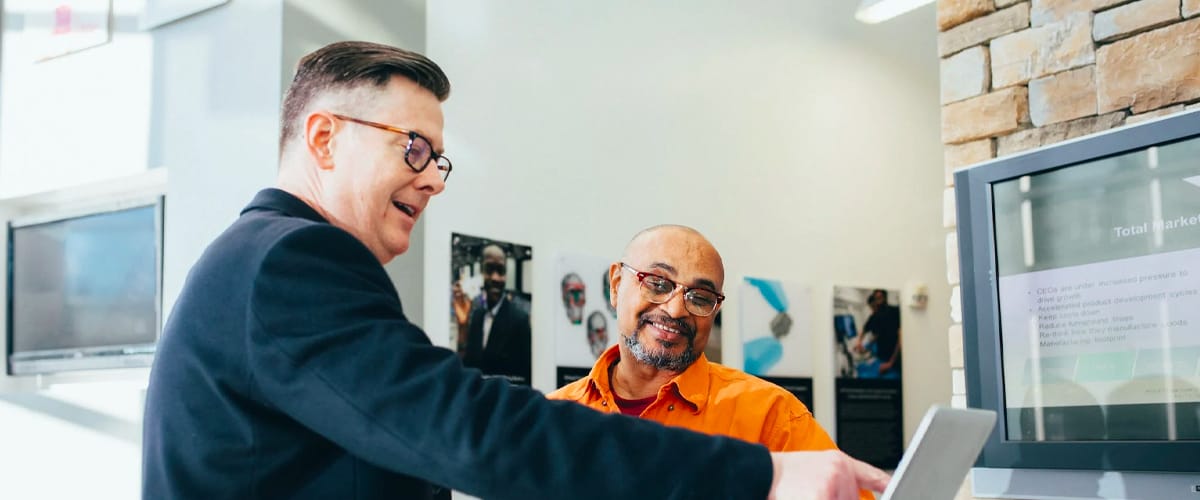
[462, 294, 533, 385]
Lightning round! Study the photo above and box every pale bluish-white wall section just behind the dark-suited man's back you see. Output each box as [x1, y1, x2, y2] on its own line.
[151, 0, 282, 314]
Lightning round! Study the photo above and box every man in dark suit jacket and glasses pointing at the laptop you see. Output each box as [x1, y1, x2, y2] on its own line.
[143, 42, 887, 500]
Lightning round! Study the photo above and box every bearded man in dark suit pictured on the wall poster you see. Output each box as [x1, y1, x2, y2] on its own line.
[462, 245, 532, 385]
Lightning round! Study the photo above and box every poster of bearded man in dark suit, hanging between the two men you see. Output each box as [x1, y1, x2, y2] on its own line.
[450, 234, 533, 385]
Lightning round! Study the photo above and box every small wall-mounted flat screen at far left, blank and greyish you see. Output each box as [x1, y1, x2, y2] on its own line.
[8, 196, 161, 374]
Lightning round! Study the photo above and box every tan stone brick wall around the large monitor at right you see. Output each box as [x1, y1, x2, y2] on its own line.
[937, 0, 1200, 499]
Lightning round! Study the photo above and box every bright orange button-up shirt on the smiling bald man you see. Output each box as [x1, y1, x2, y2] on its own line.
[547, 345, 875, 499]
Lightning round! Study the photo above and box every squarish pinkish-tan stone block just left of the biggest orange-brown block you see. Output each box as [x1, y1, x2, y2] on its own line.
[1030, 66, 1096, 127]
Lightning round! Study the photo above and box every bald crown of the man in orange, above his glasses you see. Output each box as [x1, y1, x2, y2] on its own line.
[622, 224, 725, 291]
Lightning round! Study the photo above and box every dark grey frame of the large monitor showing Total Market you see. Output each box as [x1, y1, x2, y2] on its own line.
[954, 110, 1200, 472]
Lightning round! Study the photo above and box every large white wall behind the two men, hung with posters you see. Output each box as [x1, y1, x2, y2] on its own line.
[425, 0, 950, 443]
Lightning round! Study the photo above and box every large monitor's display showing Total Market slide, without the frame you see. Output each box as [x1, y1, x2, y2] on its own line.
[991, 138, 1200, 441]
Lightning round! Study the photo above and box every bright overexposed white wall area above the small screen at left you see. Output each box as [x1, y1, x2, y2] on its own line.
[0, 0, 154, 198]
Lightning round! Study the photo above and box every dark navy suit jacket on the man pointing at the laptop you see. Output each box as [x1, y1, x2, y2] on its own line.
[143, 189, 772, 500]
